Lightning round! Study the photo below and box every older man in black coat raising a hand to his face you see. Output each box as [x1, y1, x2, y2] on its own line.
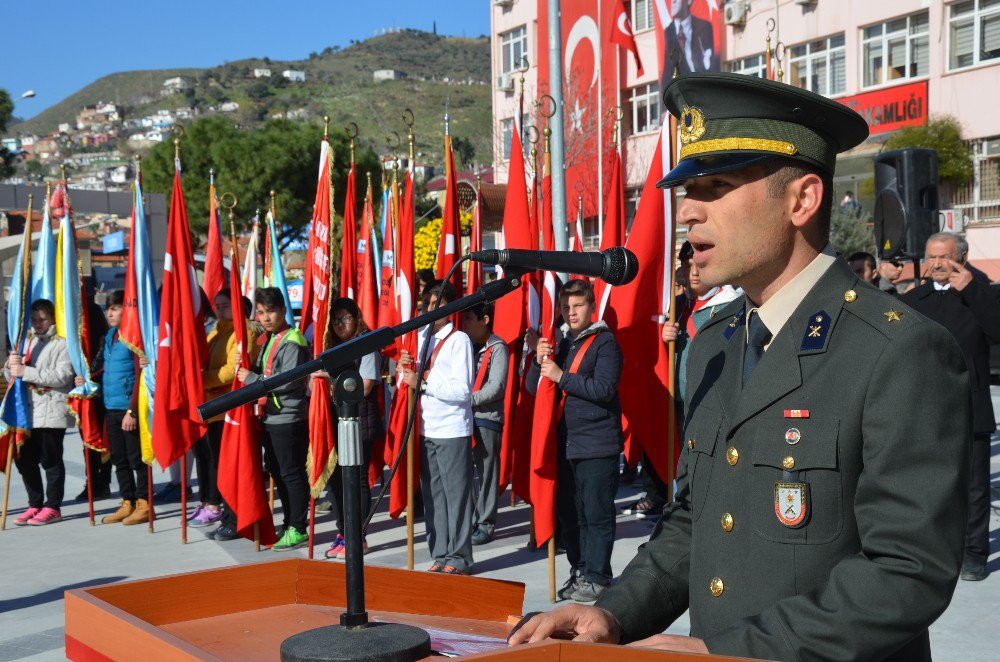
[903, 232, 1000, 581]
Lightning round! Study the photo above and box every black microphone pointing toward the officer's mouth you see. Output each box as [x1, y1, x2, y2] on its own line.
[469, 246, 639, 285]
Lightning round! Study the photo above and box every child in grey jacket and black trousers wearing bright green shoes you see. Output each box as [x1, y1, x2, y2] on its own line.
[234, 287, 309, 551]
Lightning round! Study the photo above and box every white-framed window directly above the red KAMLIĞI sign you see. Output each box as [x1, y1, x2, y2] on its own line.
[861, 12, 929, 87]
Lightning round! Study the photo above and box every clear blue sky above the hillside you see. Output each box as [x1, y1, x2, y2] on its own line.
[0, 0, 490, 119]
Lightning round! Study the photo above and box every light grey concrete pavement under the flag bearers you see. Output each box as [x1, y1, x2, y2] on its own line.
[0, 402, 1000, 662]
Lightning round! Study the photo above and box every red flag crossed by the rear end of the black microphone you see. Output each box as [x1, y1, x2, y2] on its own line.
[493, 131, 537, 491]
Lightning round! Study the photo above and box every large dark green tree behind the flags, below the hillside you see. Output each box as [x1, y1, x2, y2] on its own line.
[142, 117, 379, 247]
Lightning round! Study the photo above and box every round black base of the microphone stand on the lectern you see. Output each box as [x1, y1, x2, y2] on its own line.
[281, 623, 431, 662]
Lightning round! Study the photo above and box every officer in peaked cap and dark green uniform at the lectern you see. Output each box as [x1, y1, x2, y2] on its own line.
[511, 73, 972, 660]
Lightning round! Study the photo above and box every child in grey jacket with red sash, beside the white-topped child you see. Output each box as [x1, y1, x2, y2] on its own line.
[462, 302, 510, 545]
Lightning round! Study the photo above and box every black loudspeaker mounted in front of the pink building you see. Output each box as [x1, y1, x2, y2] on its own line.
[874, 147, 938, 259]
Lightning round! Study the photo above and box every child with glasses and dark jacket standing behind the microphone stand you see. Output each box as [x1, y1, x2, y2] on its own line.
[320, 297, 385, 559]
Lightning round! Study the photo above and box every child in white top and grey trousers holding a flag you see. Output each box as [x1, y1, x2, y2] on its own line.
[397, 283, 474, 575]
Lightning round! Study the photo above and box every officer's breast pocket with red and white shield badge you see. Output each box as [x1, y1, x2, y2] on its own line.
[743, 418, 844, 545]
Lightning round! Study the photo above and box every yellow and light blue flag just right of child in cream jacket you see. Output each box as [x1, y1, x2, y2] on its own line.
[55, 214, 100, 398]
